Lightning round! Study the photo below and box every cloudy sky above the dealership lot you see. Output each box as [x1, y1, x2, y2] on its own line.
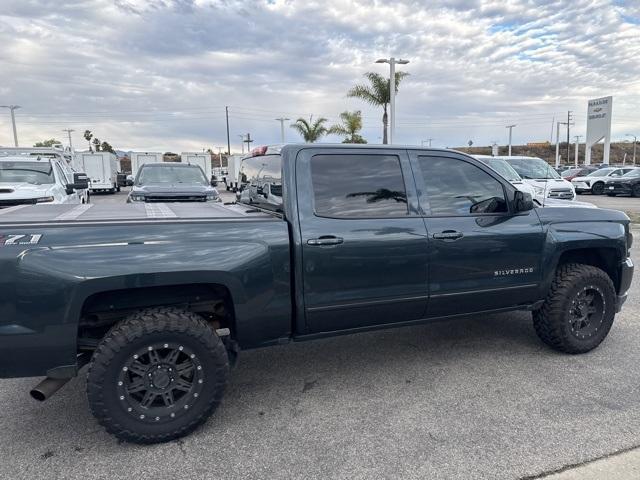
[0, 0, 640, 152]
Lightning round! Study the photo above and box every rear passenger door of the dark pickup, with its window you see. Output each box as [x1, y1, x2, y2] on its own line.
[296, 148, 428, 333]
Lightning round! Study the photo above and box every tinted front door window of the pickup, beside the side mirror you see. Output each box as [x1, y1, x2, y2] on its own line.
[418, 157, 508, 216]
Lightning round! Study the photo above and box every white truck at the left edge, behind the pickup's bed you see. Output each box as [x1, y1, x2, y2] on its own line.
[0, 155, 88, 208]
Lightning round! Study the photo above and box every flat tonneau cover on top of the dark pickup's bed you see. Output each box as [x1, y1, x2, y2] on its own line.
[0, 203, 276, 226]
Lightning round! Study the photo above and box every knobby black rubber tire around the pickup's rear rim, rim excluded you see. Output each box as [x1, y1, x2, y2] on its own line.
[87, 307, 229, 443]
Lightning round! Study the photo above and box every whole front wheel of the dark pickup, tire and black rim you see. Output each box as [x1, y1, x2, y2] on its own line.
[533, 263, 616, 353]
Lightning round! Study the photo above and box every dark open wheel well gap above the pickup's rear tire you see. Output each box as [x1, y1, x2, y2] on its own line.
[78, 283, 236, 349]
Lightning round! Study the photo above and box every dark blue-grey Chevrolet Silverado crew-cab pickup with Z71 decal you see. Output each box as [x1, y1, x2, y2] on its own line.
[0, 144, 633, 443]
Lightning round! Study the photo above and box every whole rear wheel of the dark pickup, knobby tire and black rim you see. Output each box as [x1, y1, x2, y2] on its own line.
[87, 308, 229, 443]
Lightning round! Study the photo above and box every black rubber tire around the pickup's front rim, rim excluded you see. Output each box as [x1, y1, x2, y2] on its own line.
[533, 263, 616, 353]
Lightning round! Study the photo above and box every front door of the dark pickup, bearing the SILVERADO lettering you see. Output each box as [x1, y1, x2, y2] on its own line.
[410, 151, 543, 317]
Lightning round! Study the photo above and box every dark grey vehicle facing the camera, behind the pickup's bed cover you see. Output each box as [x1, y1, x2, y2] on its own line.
[127, 162, 220, 203]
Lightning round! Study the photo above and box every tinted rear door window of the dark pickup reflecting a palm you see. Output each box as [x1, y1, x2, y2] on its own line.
[311, 155, 408, 217]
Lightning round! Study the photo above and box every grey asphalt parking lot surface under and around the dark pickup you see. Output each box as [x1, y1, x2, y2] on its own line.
[0, 192, 640, 479]
